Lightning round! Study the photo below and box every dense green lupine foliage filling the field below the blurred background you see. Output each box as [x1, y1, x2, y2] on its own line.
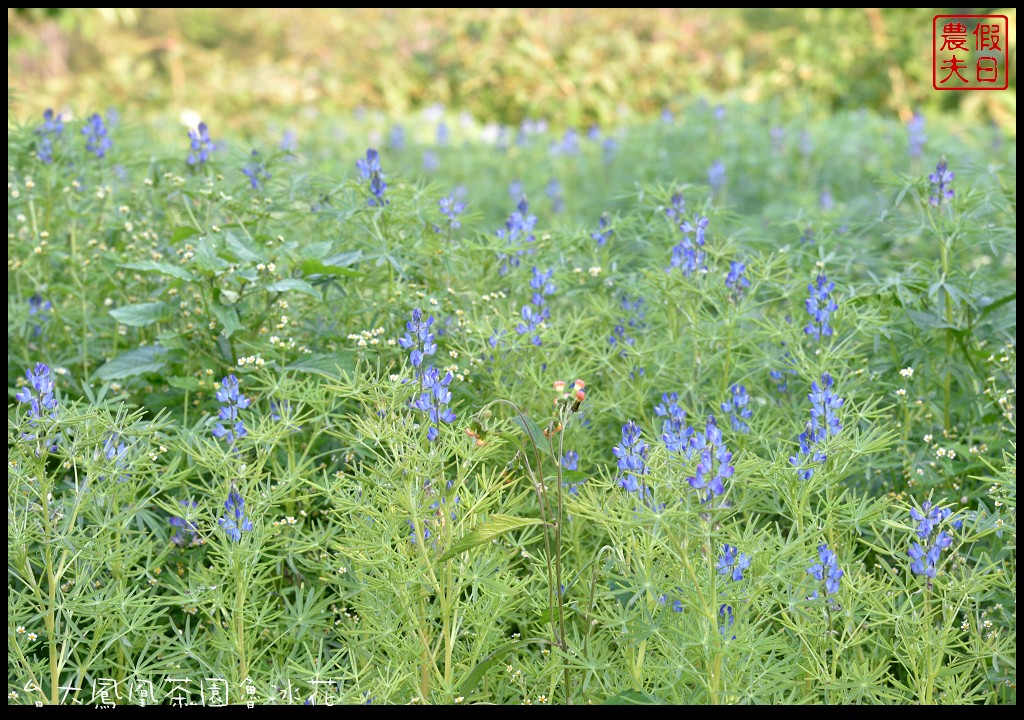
[8, 97, 1016, 704]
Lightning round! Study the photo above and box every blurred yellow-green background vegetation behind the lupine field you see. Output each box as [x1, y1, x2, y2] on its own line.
[7, 8, 1017, 137]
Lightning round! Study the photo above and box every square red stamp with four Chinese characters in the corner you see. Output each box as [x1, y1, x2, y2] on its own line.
[932, 15, 1010, 90]
